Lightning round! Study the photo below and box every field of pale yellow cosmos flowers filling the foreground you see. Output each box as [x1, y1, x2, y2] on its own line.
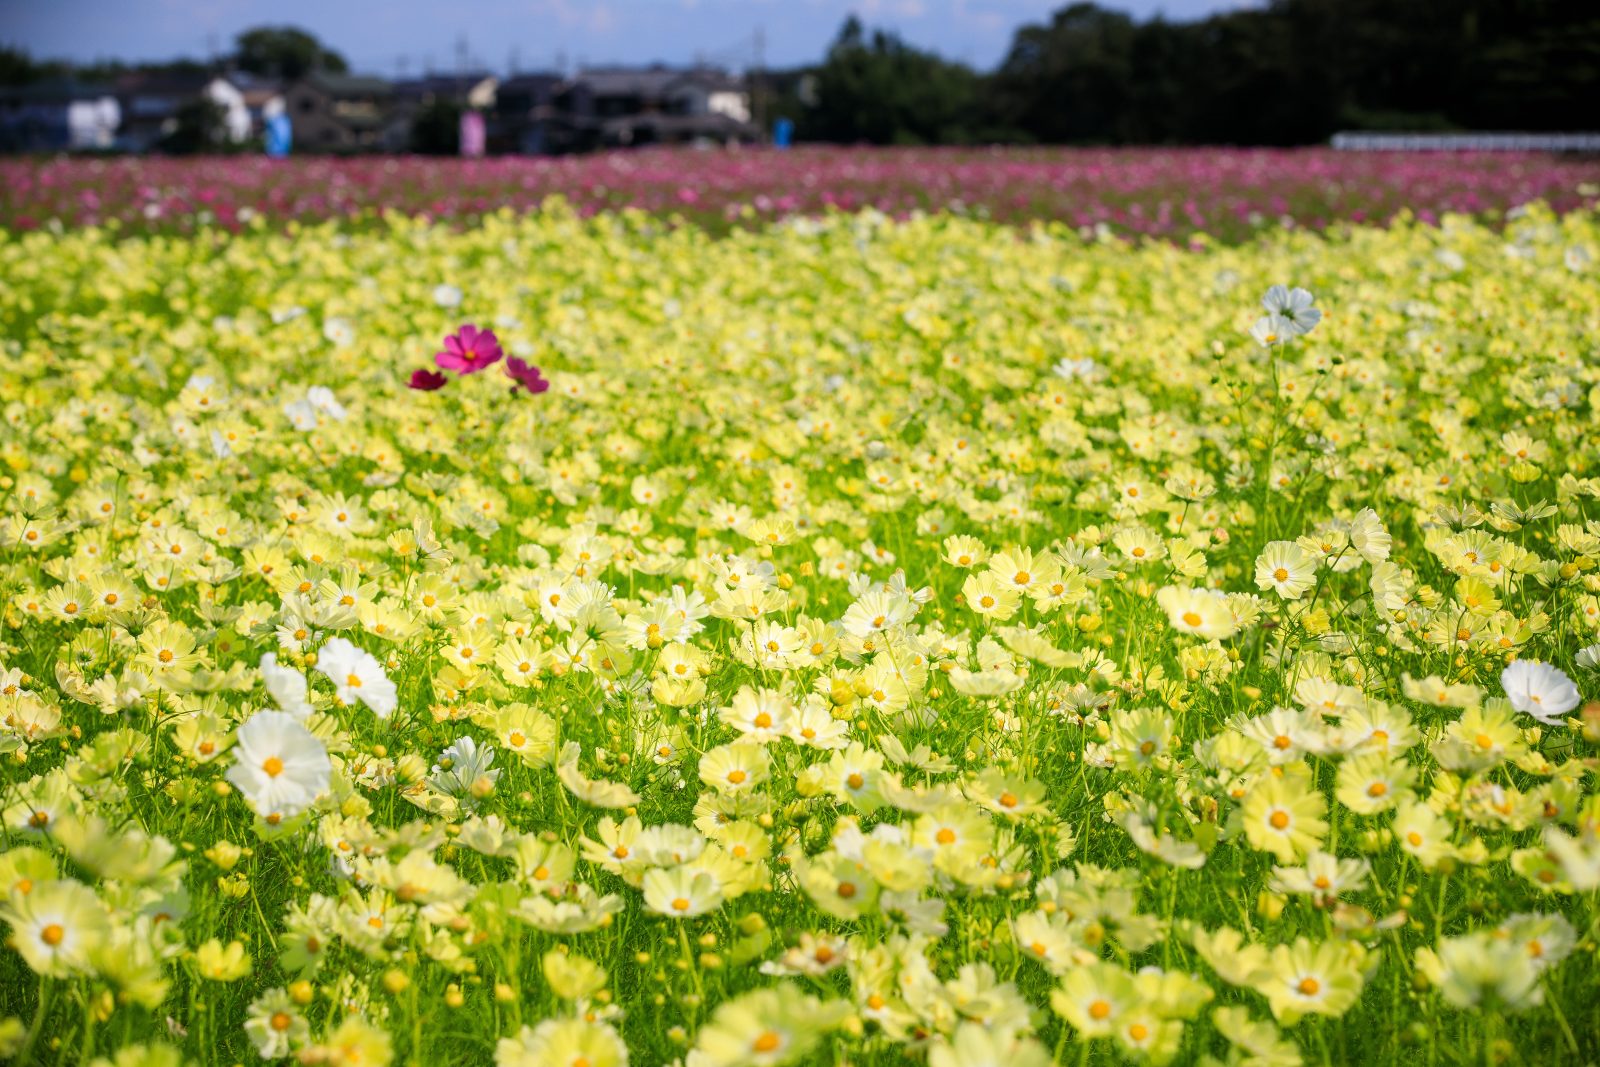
[0, 168, 1600, 1067]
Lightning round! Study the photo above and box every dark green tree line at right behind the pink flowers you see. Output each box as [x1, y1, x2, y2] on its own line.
[770, 0, 1600, 146]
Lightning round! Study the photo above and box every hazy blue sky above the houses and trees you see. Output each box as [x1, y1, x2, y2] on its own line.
[0, 0, 1261, 75]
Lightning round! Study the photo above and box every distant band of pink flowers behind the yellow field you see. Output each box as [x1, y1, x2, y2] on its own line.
[0, 149, 1600, 237]
